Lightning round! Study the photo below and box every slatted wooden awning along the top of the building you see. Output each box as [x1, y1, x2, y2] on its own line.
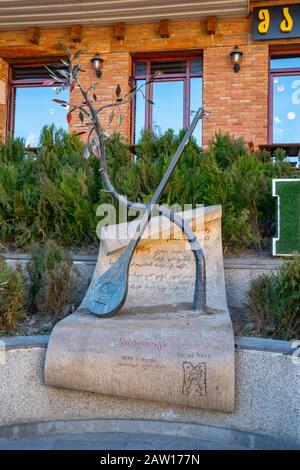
[0, 0, 248, 30]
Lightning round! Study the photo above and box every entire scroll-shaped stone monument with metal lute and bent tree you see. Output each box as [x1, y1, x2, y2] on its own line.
[45, 48, 234, 411]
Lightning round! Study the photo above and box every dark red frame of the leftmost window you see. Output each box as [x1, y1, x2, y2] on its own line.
[6, 57, 68, 134]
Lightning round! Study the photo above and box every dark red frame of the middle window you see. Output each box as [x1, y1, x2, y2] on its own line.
[131, 51, 203, 144]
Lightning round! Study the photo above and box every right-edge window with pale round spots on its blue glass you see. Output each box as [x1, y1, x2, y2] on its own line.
[270, 56, 300, 144]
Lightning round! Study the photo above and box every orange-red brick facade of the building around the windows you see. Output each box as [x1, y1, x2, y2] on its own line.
[0, 0, 300, 146]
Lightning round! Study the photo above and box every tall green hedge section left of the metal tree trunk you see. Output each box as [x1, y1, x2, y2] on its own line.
[0, 125, 100, 246]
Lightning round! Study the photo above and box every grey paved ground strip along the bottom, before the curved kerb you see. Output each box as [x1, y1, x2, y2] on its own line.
[0, 433, 246, 451]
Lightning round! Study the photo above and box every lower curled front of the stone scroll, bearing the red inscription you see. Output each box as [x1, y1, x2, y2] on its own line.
[45, 305, 234, 411]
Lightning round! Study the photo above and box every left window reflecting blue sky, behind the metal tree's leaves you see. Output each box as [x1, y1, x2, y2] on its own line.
[8, 63, 69, 147]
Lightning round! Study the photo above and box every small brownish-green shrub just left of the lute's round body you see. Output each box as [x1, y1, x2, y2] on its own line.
[27, 240, 76, 317]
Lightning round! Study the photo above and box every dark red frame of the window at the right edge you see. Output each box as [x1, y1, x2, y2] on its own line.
[268, 48, 300, 145]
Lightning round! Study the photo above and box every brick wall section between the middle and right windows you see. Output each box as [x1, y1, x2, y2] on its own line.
[203, 44, 269, 145]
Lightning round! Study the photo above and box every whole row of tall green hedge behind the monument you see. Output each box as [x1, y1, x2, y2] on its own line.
[0, 126, 292, 249]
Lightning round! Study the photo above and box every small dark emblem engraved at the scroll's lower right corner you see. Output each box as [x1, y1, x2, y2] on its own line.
[182, 362, 206, 397]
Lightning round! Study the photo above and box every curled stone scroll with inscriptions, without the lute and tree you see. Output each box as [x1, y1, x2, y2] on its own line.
[45, 206, 234, 411]
